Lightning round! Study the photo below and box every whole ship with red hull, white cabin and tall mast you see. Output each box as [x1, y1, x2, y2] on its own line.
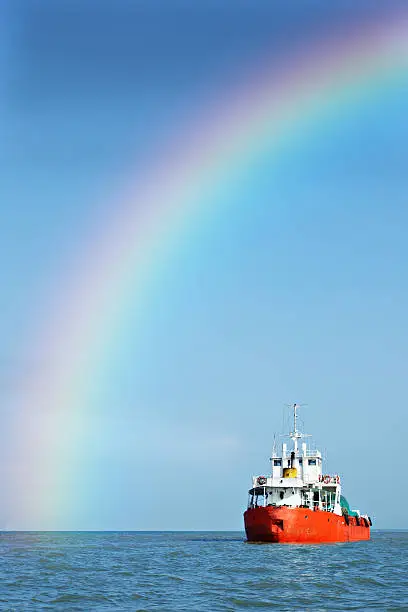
[244, 404, 372, 544]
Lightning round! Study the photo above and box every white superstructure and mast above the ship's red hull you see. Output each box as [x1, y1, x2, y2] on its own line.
[248, 404, 342, 515]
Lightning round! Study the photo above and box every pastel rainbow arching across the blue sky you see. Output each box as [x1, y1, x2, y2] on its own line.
[12, 15, 408, 528]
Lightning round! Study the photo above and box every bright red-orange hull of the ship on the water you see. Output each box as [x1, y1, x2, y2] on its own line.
[244, 506, 370, 544]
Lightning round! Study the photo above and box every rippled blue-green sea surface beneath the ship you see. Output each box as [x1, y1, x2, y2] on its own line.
[0, 531, 408, 612]
